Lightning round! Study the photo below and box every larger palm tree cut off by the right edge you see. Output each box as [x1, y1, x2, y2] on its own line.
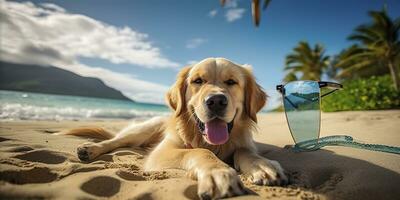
[337, 9, 400, 91]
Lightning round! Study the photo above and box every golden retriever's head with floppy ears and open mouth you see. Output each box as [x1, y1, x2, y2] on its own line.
[167, 58, 266, 145]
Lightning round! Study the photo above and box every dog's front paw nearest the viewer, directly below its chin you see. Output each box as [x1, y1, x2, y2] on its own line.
[198, 167, 246, 199]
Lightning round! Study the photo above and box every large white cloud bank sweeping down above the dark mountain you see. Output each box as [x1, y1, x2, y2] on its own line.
[0, 0, 180, 103]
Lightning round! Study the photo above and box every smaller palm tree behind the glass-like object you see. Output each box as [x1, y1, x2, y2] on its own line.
[285, 41, 329, 81]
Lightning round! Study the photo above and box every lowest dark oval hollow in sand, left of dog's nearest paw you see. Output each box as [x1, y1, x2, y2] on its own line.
[81, 176, 121, 197]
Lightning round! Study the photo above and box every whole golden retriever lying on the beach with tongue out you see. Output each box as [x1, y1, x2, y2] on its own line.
[62, 58, 288, 199]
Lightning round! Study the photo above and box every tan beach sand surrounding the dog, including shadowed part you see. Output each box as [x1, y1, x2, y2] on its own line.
[0, 110, 400, 199]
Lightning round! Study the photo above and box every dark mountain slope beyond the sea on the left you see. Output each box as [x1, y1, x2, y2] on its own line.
[0, 61, 132, 101]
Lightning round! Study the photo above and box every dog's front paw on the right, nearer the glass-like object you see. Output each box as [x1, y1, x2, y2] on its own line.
[249, 158, 288, 186]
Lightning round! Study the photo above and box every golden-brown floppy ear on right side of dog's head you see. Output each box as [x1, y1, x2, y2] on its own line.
[244, 67, 268, 122]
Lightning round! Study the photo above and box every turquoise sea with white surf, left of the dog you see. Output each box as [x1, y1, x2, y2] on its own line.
[0, 90, 170, 120]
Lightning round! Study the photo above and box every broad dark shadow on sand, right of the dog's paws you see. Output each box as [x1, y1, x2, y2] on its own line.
[257, 143, 400, 199]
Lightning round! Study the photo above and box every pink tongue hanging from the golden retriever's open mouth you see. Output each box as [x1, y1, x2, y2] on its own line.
[205, 119, 229, 145]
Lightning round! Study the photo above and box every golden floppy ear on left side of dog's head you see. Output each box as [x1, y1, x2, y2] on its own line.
[166, 67, 190, 116]
